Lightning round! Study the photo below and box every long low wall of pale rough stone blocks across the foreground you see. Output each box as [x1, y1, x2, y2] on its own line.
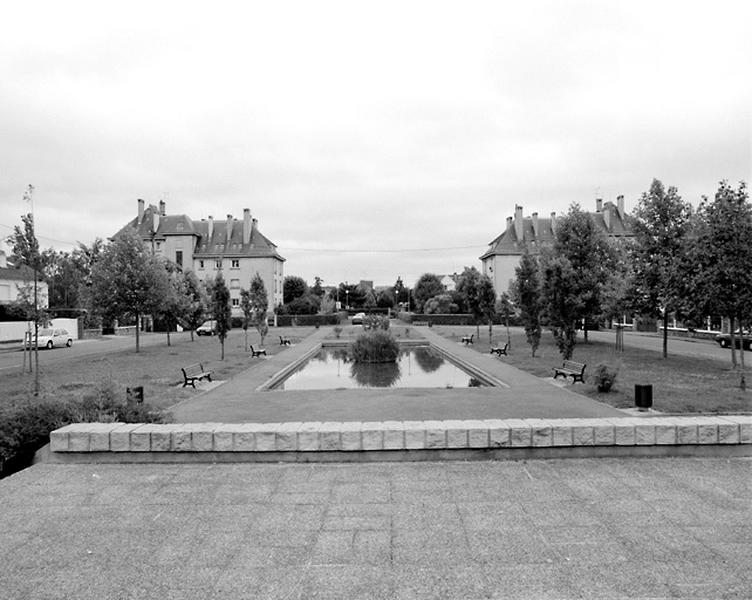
[50, 415, 752, 454]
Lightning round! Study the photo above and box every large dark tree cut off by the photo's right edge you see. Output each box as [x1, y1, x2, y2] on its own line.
[690, 181, 752, 388]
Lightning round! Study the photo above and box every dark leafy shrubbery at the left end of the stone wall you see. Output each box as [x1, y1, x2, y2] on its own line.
[0, 382, 169, 477]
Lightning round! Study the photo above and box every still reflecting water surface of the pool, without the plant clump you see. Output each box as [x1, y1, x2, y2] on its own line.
[272, 346, 485, 390]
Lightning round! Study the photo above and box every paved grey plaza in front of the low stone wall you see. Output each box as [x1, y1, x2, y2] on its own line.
[0, 458, 752, 600]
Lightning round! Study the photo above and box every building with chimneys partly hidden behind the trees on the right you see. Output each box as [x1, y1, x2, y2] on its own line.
[480, 196, 634, 296]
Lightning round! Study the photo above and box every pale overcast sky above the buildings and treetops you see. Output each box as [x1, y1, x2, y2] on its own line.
[0, 0, 752, 284]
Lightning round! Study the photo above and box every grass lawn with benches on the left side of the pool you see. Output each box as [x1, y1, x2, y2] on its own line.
[0, 327, 314, 409]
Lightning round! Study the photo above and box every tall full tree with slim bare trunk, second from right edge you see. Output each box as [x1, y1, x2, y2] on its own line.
[632, 179, 692, 358]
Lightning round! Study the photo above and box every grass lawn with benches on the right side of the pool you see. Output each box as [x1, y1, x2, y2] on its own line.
[433, 325, 752, 413]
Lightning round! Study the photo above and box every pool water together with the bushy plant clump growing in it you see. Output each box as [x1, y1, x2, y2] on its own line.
[274, 330, 481, 391]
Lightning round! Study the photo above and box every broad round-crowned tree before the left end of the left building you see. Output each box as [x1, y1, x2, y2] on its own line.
[91, 230, 169, 352]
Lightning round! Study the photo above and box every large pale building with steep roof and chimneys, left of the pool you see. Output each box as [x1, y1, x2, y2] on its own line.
[113, 200, 285, 316]
